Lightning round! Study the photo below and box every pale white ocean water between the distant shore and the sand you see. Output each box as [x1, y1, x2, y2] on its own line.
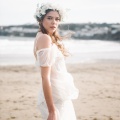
[0, 37, 120, 65]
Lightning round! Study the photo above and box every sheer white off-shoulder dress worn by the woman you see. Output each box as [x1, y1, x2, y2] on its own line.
[36, 44, 79, 120]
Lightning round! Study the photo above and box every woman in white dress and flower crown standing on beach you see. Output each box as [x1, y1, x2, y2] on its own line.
[34, 3, 79, 120]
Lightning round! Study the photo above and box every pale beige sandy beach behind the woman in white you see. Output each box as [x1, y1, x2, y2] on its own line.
[0, 61, 120, 120]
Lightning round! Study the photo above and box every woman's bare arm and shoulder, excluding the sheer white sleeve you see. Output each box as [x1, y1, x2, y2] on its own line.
[37, 35, 55, 117]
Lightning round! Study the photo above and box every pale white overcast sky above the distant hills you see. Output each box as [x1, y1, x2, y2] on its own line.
[0, 0, 120, 26]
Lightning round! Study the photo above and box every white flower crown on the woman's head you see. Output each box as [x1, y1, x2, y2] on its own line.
[34, 3, 65, 20]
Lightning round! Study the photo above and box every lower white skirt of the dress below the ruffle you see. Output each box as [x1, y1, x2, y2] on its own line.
[38, 100, 77, 120]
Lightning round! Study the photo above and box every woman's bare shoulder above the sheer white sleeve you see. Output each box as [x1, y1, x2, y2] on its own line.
[36, 34, 52, 49]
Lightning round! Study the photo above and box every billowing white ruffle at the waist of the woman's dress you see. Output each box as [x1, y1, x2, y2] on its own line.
[51, 73, 79, 101]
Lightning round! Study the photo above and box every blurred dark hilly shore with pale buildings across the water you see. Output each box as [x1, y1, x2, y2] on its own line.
[0, 23, 120, 41]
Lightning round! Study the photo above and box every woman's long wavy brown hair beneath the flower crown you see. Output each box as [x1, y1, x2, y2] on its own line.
[36, 9, 70, 57]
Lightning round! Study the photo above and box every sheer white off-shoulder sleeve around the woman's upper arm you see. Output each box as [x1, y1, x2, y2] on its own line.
[36, 48, 55, 67]
